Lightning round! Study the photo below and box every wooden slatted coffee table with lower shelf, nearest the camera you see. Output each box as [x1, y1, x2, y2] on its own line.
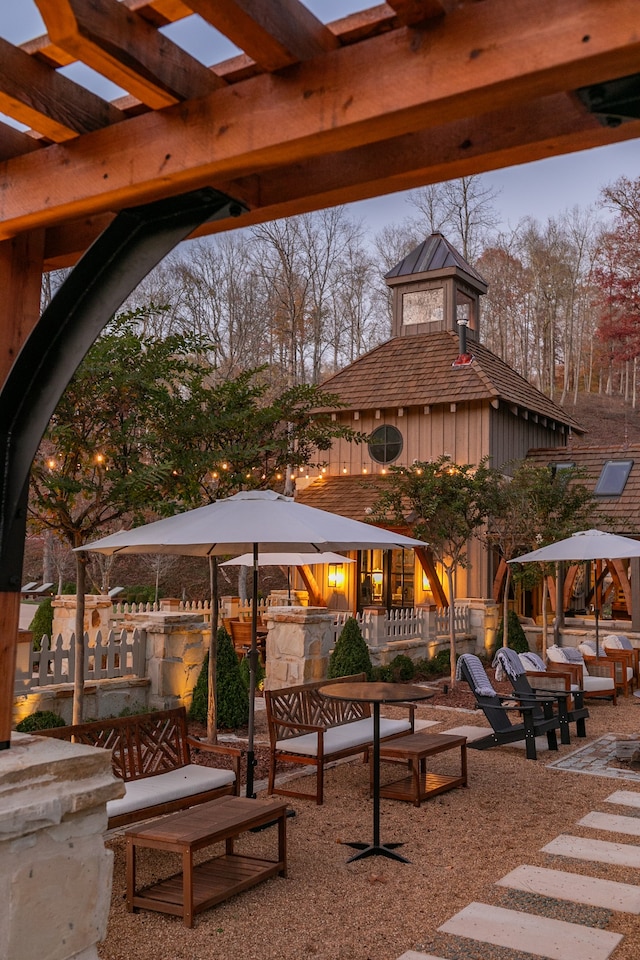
[125, 797, 287, 927]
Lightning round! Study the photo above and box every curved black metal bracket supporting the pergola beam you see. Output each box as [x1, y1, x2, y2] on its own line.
[0, 188, 246, 593]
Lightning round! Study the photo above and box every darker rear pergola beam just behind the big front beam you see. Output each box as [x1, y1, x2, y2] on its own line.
[45, 94, 640, 269]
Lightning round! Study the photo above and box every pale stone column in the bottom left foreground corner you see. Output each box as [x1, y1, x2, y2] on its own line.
[0, 733, 124, 960]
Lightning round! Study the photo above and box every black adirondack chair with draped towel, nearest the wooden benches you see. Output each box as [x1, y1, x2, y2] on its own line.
[456, 653, 560, 760]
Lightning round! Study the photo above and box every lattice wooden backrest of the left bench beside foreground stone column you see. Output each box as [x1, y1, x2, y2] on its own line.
[39, 707, 190, 781]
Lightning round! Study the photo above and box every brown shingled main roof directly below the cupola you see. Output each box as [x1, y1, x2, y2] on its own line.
[322, 330, 584, 433]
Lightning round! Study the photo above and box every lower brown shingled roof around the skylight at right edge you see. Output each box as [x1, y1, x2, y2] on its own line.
[527, 443, 640, 536]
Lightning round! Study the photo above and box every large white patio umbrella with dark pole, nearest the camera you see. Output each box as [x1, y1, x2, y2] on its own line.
[77, 490, 426, 796]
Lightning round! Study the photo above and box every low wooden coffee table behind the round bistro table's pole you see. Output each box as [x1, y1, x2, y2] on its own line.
[380, 733, 467, 807]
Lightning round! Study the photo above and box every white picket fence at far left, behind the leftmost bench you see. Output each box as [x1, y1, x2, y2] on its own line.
[16, 630, 146, 688]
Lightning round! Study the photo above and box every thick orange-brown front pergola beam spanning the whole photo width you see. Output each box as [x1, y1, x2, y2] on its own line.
[0, 0, 640, 237]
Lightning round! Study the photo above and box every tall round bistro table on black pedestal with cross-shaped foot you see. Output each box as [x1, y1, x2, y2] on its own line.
[319, 682, 436, 863]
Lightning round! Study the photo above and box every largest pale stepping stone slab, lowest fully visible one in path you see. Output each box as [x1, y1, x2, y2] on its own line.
[438, 903, 622, 960]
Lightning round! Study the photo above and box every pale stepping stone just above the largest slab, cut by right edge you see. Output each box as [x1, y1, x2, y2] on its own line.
[497, 866, 640, 913]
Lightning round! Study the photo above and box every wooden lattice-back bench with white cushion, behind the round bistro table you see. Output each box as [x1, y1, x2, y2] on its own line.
[265, 673, 415, 804]
